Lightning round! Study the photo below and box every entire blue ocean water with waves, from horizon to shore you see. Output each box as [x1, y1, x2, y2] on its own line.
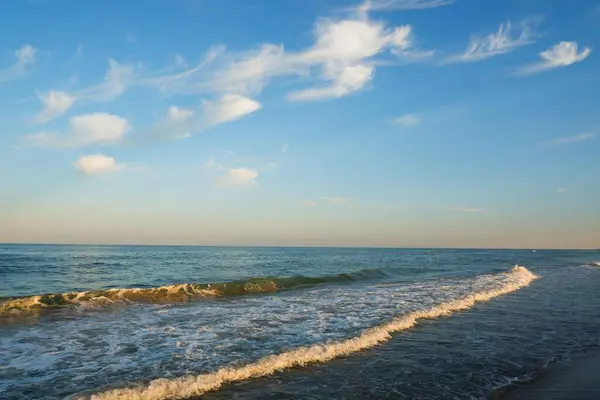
[0, 245, 600, 400]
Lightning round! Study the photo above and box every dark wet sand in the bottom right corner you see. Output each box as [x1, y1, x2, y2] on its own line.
[494, 352, 600, 400]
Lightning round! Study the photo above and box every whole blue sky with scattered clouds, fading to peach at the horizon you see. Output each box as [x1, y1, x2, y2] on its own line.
[0, 0, 600, 248]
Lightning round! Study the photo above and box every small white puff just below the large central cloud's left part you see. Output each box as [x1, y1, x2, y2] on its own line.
[203, 94, 261, 126]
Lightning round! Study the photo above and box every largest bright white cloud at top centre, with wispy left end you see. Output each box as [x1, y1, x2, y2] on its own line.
[204, 18, 424, 101]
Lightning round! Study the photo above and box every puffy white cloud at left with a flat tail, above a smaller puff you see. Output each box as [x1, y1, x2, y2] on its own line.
[25, 113, 131, 148]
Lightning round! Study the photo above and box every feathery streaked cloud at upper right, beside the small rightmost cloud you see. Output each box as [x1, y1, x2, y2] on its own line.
[446, 21, 535, 62]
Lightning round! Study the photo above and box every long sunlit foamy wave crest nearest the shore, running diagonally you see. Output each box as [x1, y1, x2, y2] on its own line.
[69, 265, 538, 400]
